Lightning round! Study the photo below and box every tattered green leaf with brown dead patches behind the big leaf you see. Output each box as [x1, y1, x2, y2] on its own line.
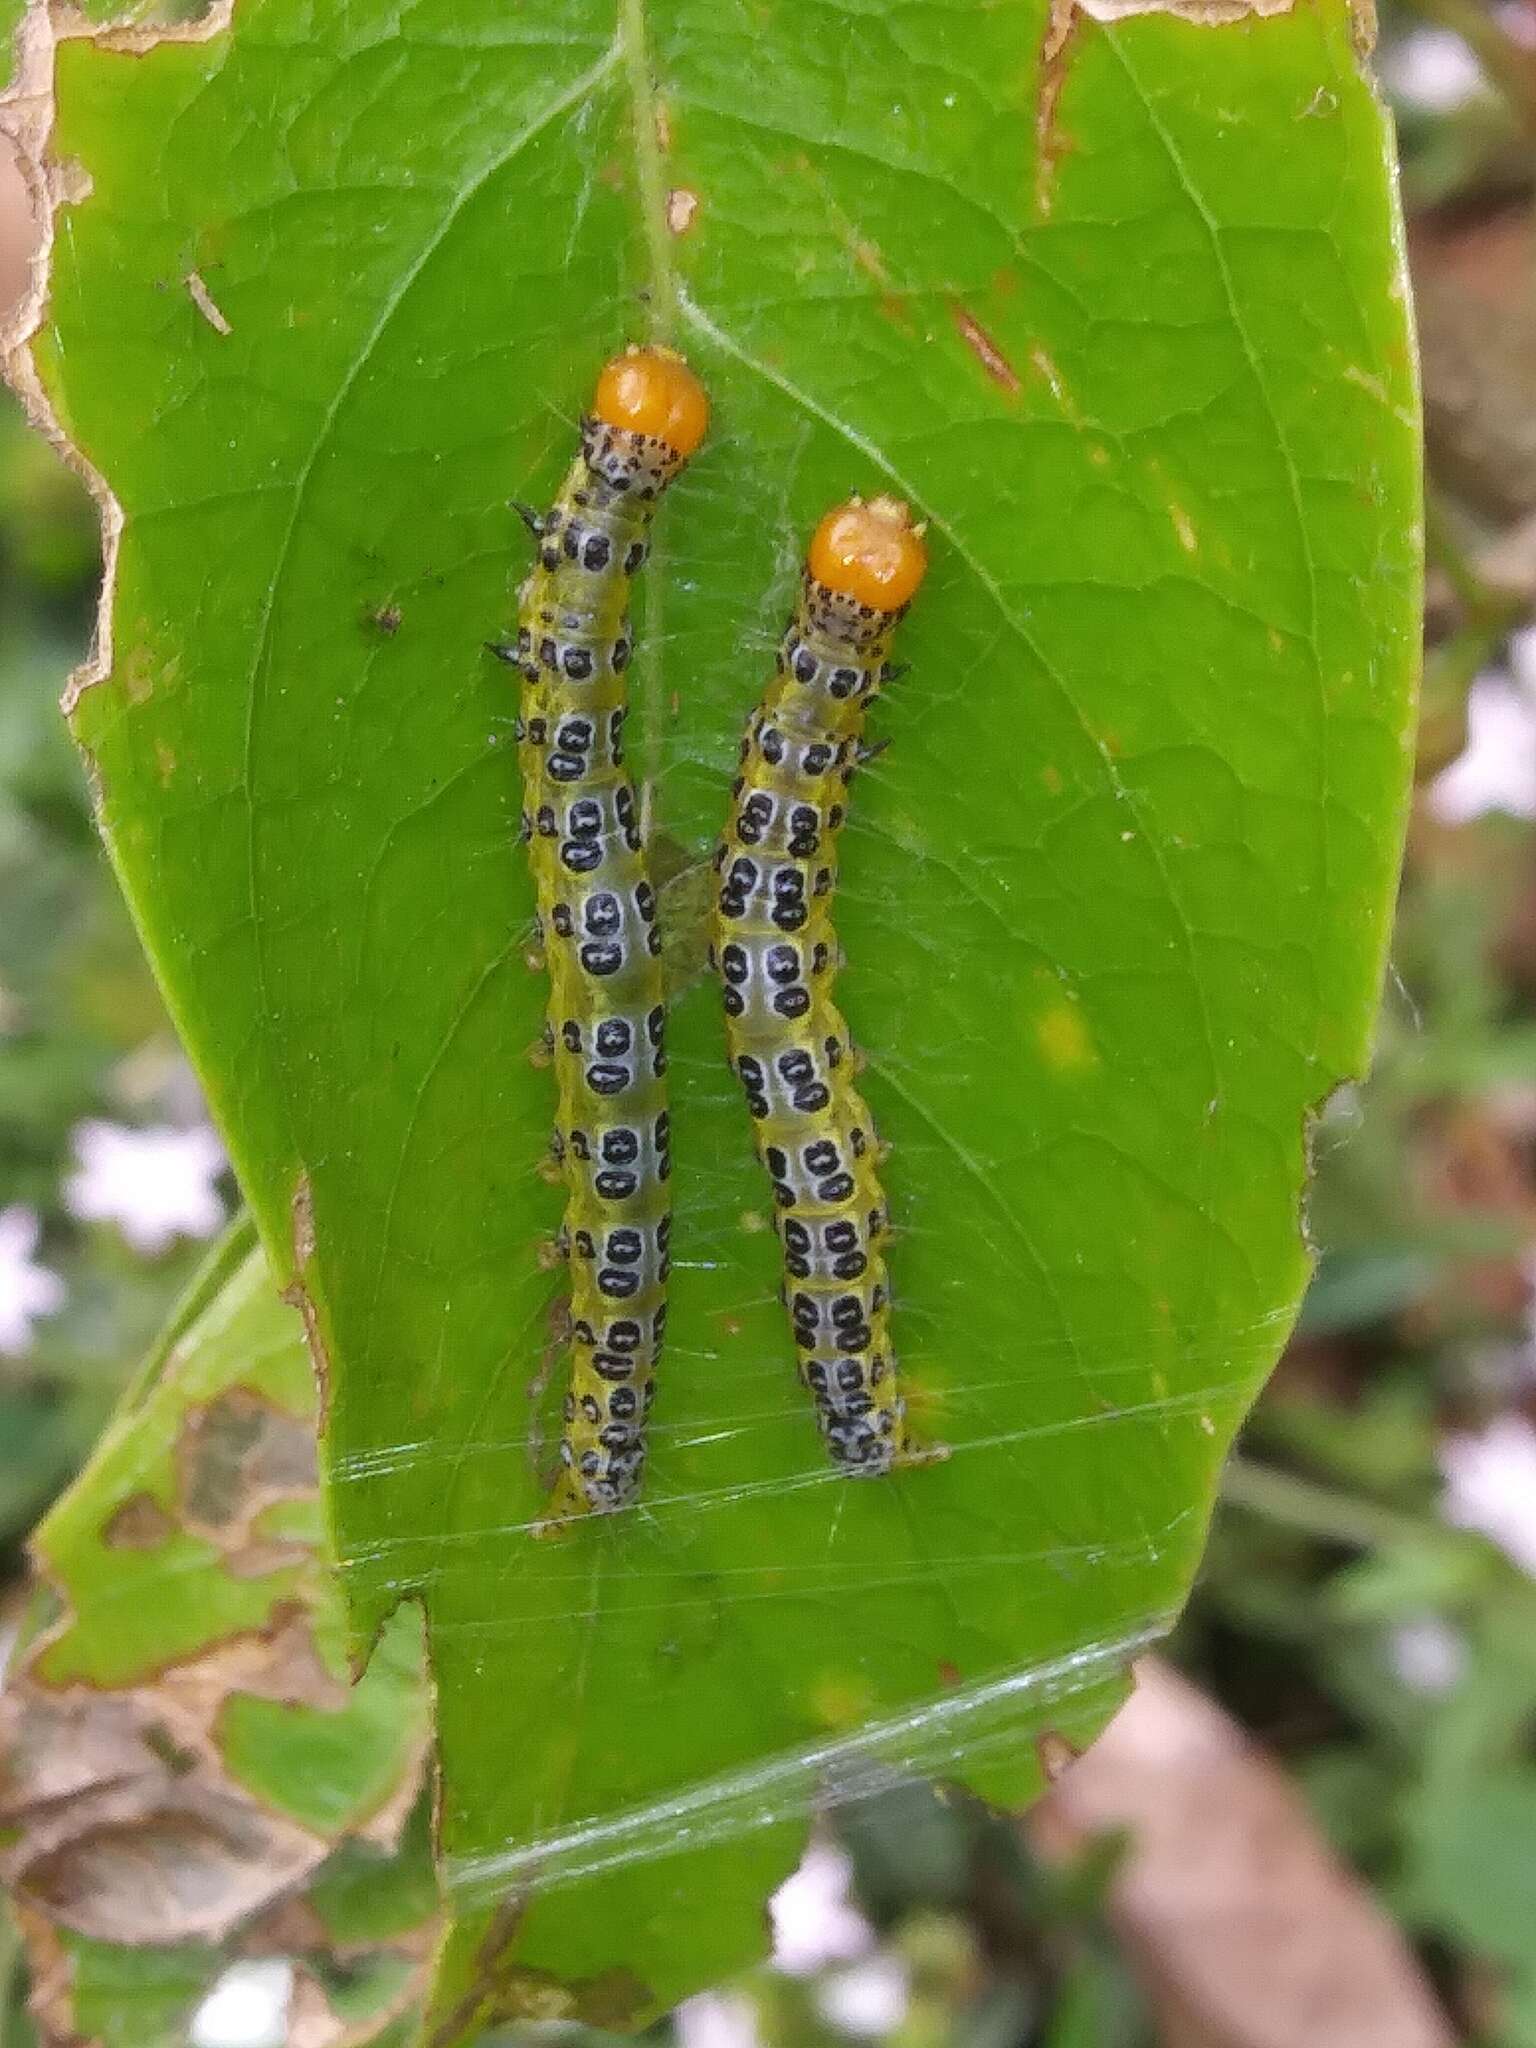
[0, 1225, 436, 2048]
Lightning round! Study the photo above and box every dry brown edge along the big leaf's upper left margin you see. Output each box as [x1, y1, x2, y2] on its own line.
[0, 0, 236, 719]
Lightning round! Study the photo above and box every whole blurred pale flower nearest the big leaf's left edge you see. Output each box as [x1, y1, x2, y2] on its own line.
[63, 1120, 223, 1255]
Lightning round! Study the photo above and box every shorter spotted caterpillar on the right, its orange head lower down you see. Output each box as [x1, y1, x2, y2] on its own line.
[711, 498, 938, 1475]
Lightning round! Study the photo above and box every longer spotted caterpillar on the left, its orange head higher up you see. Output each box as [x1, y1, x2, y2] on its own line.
[494, 348, 709, 1524]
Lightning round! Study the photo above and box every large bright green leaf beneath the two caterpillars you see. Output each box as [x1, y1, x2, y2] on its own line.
[24, 0, 1417, 2042]
